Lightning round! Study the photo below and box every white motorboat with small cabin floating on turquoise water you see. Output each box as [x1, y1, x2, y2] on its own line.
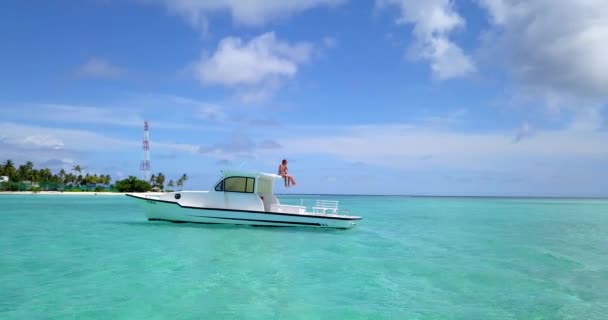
[127, 170, 361, 229]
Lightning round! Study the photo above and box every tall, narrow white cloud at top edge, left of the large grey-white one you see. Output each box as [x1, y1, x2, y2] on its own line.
[376, 0, 475, 80]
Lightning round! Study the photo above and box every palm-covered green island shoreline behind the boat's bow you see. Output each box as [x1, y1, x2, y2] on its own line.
[0, 159, 188, 193]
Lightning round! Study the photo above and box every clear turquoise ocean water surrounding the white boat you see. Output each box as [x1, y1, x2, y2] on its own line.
[0, 195, 608, 320]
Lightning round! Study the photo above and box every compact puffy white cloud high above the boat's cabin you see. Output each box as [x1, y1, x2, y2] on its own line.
[194, 32, 314, 102]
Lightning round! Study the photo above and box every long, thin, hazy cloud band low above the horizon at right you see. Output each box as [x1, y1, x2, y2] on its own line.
[281, 117, 608, 170]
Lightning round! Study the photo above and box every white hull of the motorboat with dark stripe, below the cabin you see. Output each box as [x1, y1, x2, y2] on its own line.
[128, 195, 361, 229]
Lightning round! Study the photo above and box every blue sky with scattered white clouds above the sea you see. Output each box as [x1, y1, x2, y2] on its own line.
[0, 0, 608, 196]
